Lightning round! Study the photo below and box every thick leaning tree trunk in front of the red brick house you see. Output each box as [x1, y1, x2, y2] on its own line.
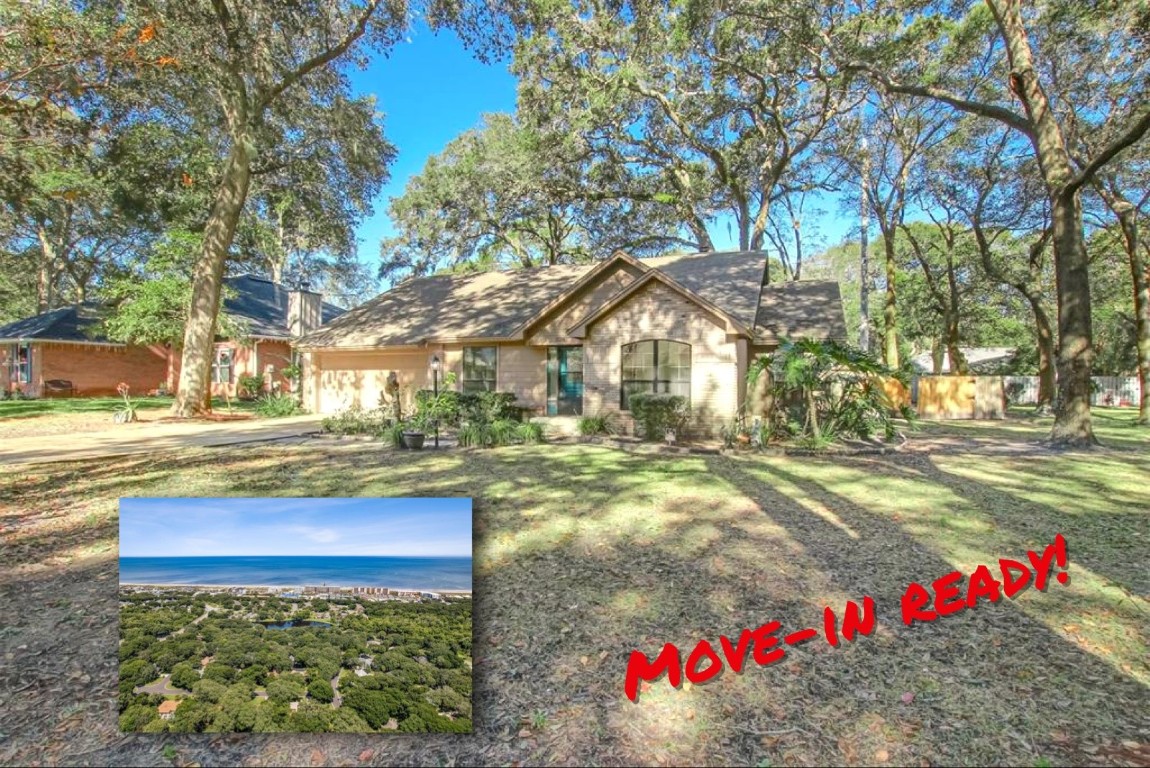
[171, 135, 251, 418]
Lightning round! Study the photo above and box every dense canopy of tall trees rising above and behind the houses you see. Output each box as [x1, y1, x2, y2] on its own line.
[0, 0, 1150, 432]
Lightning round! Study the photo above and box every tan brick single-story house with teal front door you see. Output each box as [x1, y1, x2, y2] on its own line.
[298, 252, 846, 433]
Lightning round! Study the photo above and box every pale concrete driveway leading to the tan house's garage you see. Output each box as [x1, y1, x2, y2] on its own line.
[0, 415, 322, 464]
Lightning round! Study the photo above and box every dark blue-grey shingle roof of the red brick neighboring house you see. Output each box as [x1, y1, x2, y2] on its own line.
[0, 275, 344, 344]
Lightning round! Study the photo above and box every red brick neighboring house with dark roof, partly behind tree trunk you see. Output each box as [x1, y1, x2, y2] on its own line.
[0, 275, 343, 397]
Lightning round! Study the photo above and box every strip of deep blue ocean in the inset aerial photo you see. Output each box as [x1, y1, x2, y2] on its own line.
[120, 556, 472, 590]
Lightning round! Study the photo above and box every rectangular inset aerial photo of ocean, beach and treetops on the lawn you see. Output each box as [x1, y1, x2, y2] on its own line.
[120, 498, 472, 734]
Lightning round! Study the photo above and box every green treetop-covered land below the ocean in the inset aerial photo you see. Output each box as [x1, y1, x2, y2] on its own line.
[120, 590, 472, 732]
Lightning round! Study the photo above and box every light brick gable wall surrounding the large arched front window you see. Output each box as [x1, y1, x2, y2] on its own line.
[583, 283, 739, 435]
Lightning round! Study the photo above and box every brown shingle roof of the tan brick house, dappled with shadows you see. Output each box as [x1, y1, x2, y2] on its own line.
[300, 251, 845, 348]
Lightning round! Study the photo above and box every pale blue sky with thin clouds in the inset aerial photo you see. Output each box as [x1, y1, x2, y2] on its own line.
[120, 498, 472, 558]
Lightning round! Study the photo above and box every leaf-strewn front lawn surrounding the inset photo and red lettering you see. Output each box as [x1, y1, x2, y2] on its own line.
[0, 436, 1150, 766]
